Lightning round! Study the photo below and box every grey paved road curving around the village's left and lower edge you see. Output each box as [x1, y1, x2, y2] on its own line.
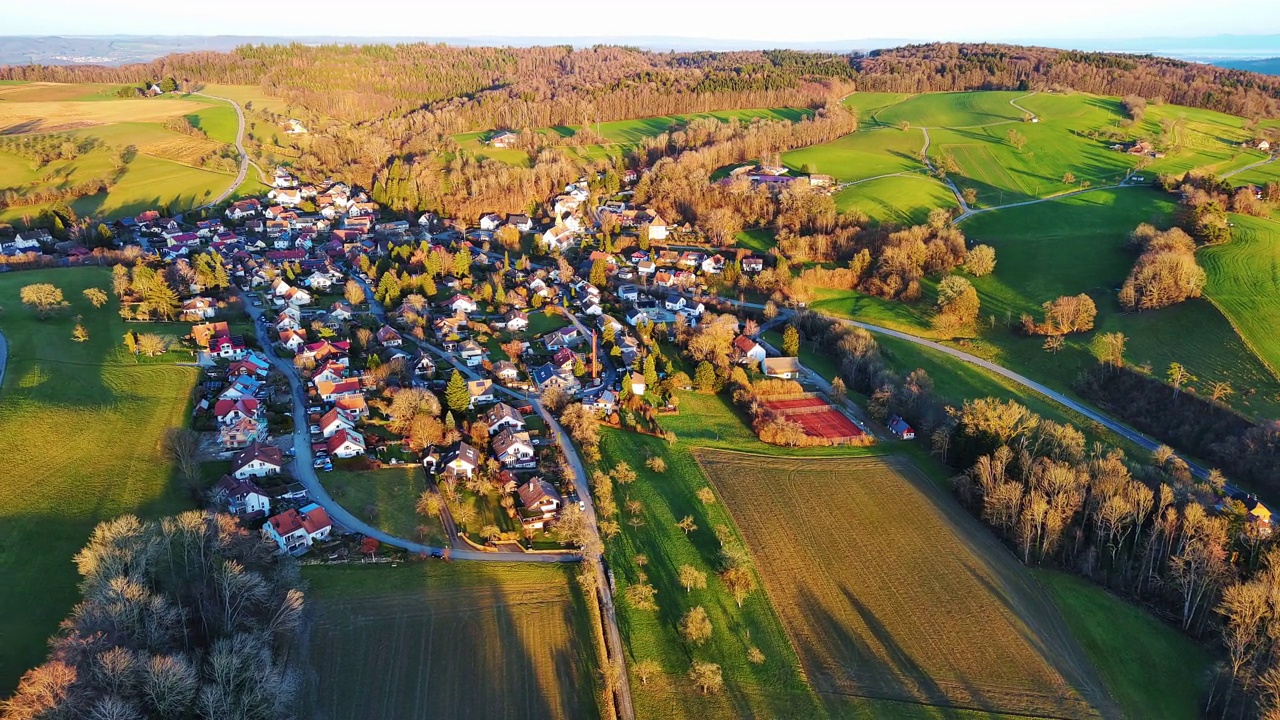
[241, 285, 579, 562]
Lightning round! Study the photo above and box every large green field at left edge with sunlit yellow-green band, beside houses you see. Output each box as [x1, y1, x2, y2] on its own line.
[0, 268, 197, 694]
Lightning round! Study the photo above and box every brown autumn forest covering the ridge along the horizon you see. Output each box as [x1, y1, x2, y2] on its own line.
[0, 44, 1280, 207]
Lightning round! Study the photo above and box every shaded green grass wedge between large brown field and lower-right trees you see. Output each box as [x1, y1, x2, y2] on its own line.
[1034, 570, 1211, 720]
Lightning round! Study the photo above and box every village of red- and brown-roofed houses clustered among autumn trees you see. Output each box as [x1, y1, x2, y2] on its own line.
[0, 156, 890, 557]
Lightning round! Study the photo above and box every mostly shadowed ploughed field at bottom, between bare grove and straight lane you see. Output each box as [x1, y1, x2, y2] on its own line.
[303, 562, 600, 720]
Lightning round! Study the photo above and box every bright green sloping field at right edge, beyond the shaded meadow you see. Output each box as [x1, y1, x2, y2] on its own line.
[1198, 215, 1280, 372]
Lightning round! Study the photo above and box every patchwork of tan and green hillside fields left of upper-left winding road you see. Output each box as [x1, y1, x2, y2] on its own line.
[0, 83, 244, 222]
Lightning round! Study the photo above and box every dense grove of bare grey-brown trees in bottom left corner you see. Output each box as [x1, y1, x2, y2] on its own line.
[0, 511, 305, 720]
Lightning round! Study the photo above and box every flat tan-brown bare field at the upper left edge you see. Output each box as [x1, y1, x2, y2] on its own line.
[0, 96, 209, 135]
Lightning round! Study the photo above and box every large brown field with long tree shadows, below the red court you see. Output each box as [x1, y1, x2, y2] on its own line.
[695, 450, 1115, 717]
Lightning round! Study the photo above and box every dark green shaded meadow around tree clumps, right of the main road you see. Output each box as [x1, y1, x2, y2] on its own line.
[962, 188, 1280, 416]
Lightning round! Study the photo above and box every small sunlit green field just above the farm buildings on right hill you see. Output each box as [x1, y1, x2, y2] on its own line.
[782, 128, 924, 182]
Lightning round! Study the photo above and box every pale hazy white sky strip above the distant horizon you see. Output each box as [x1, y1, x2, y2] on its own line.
[0, 0, 1280, 44]
